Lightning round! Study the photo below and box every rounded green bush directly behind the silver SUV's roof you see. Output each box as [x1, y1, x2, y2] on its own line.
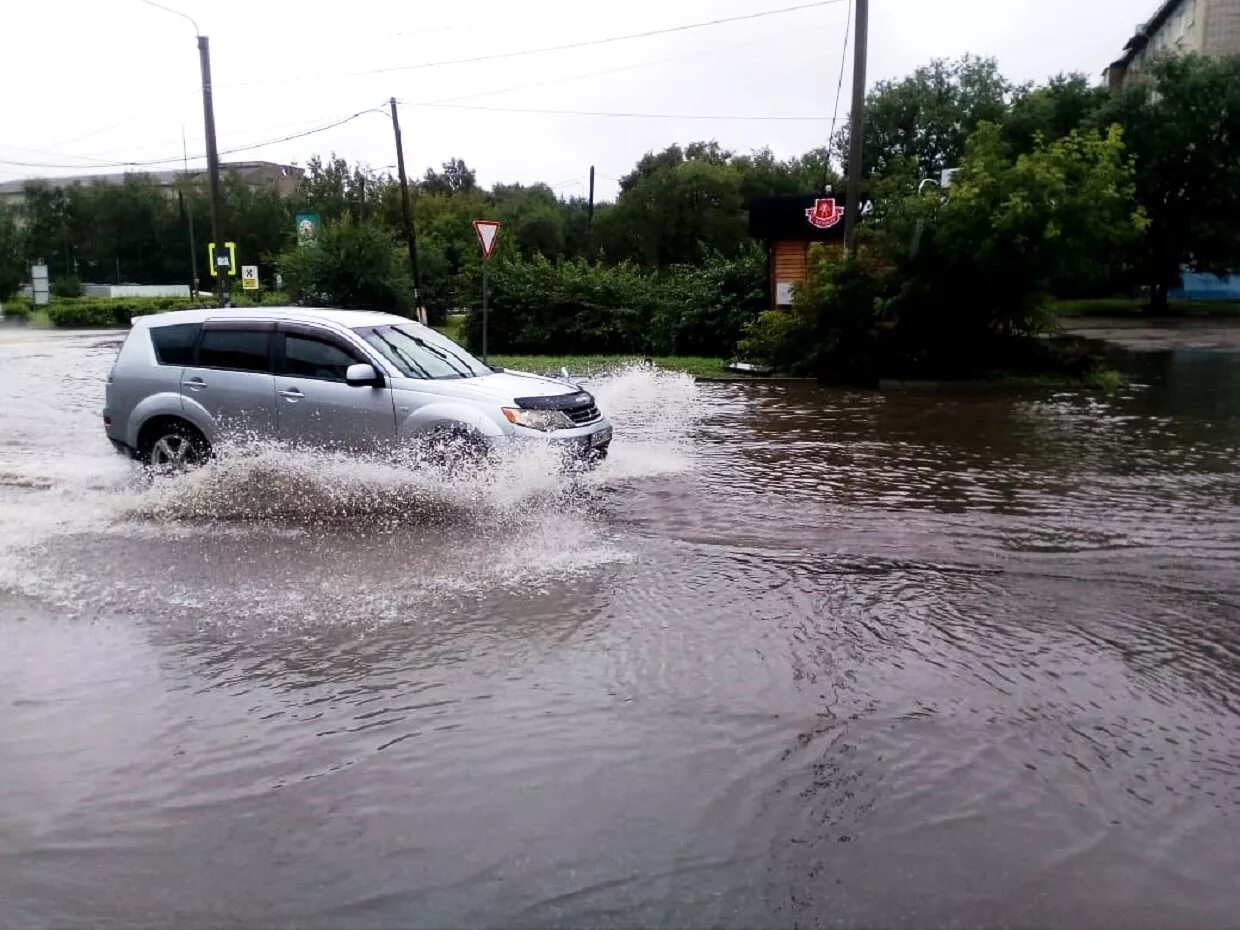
[277, 217, 413, 314]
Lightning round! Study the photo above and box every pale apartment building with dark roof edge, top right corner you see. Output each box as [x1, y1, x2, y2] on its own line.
[1106, 0, 1240, 88]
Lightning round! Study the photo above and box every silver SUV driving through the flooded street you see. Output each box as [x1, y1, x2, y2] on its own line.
[103, 308, 611, 470]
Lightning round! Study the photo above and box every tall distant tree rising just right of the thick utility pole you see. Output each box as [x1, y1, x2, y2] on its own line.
[835, 55, 1013, 177]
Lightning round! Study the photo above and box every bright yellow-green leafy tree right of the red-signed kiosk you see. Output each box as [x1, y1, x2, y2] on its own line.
[892, 123, 1145, 360]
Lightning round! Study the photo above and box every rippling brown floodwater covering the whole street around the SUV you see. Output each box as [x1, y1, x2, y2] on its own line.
[0, 330, 1240, 930]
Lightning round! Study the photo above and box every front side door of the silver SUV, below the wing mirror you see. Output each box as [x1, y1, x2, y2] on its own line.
[275, 324, 396, 450]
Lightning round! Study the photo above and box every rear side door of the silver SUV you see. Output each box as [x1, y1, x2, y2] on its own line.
[181, 320, 277, 440]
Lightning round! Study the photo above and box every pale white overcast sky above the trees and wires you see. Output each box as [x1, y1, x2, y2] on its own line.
[0, 0, 1140, 200]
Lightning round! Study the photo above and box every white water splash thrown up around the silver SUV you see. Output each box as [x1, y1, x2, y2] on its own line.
[0, 366, 704, 629]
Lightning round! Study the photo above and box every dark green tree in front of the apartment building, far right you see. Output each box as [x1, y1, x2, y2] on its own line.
[1097, 55, 1240, 310]
